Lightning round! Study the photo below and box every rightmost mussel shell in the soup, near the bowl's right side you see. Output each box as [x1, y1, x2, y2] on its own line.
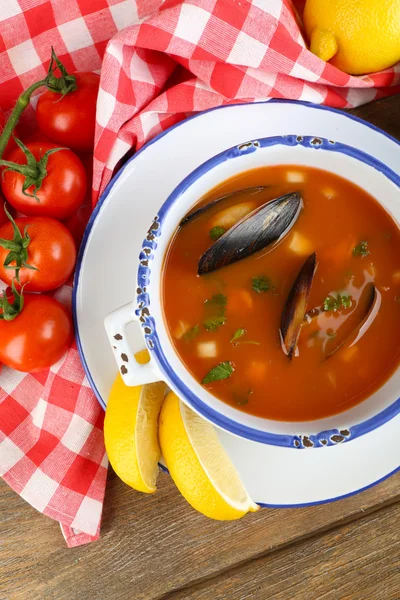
[325, 283, 382, 358]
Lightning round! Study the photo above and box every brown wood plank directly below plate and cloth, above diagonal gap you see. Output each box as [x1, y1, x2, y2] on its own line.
[0, 474, 400, 600]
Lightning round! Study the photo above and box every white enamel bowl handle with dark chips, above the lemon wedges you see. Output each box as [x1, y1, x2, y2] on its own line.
[104, 302, 163, 386]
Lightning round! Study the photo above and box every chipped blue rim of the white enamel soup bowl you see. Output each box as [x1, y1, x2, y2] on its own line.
[136, 135, 400, 449]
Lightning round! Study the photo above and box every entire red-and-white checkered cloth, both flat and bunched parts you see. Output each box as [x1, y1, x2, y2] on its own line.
[0, 0, 400, 546]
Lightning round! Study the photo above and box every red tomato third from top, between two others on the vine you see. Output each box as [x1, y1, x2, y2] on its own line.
[0, 217, 76, 292]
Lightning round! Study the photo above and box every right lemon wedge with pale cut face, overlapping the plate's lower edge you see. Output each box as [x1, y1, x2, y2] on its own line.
[159, 392, 259, 521]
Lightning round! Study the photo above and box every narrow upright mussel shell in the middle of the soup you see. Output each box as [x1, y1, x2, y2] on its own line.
[280, 252, 317, 359]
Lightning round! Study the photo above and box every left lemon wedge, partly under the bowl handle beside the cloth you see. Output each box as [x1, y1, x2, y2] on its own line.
[104, 352, 166, 494]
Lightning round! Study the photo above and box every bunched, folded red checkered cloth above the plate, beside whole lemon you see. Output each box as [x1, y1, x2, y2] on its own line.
[93, 0, 400, 200]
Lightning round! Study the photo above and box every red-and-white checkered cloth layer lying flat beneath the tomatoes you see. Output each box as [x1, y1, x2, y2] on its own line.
[0, 0, 141, 546]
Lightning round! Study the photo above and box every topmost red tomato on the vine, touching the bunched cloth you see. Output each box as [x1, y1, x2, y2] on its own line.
[36, 73, 100, 152]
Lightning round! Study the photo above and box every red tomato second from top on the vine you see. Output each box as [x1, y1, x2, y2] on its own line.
[1, 142, 86, 221]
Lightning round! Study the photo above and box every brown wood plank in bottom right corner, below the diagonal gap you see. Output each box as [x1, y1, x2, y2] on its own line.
[167, 503, 400, 600]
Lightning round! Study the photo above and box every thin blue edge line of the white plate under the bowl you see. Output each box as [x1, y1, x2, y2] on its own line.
[72, 99, 400, 508]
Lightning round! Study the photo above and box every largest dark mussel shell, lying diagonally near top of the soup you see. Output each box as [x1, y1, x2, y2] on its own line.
[198, 192, 302, 275]
